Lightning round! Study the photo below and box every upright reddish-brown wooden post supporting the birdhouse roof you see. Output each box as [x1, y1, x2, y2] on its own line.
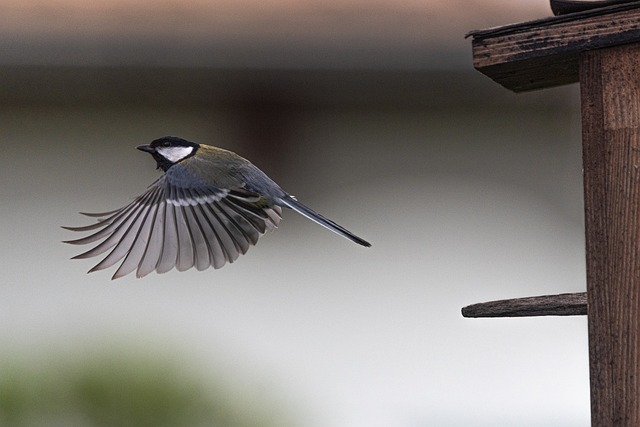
[580, 44, 640, 427]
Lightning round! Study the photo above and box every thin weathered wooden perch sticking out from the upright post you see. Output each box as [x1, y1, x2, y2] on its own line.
[462, 292, 587, 317]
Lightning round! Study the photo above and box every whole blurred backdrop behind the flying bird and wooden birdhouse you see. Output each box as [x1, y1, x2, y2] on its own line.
[0, 0, 589, 427]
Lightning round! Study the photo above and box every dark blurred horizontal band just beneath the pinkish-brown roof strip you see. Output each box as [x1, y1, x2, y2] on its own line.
[0, 66, 575, 110]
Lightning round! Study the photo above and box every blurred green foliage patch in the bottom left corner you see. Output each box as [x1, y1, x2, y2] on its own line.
[0, 355, 286, 427]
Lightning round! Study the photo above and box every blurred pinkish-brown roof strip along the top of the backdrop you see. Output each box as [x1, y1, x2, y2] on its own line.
[0, 0, 551, 69]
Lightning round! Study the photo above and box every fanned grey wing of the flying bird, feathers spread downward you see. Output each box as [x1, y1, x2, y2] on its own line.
[63, 174, 282, 279]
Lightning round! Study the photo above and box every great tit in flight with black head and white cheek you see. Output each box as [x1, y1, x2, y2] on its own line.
[63, 136, 371, 279]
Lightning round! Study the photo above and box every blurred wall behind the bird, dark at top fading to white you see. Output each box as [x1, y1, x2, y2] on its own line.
[0, 1, 589, 426]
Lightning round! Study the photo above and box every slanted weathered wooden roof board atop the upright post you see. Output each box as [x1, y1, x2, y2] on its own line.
[469, 2, 640, 92]
